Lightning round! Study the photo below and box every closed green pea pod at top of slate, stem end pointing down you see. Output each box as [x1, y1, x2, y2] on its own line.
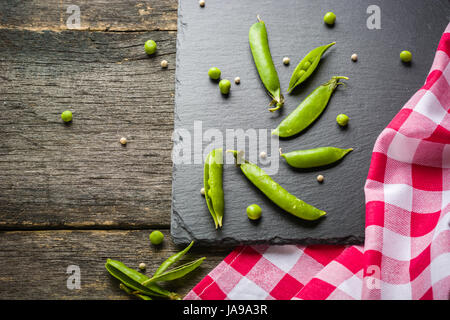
[248, 16, 284, 112]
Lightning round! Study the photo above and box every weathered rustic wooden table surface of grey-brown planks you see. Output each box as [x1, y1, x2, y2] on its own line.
[0, 0, 232, 299]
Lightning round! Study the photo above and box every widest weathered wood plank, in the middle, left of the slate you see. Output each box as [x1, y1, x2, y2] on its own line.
[0, 29, 176, 228]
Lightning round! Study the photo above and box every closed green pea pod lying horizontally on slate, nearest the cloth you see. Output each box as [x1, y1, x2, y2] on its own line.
[280, 147, 353, 169]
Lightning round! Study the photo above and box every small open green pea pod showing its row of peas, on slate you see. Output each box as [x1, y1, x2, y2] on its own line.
[288, 42, 336, 92]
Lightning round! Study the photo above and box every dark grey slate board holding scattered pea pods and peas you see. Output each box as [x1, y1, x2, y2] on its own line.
[171, 0, 449, 245]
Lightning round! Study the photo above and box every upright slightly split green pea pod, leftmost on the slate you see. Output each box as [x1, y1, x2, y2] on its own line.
[203, 149, 225, 229]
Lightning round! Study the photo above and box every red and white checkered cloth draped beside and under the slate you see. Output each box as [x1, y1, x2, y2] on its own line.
[185, 24, 450, 299]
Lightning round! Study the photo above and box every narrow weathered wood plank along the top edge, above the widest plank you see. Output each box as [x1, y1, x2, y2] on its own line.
[0, 0, 178, 31]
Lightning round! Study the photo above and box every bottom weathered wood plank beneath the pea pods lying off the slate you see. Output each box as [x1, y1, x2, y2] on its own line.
[0, 230, 231, 299]
